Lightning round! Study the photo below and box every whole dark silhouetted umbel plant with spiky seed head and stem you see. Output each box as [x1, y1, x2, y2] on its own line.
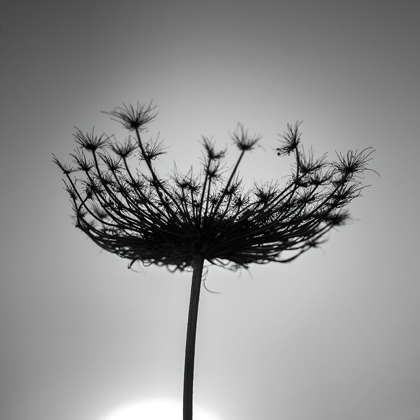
[54, 104, 373, 420]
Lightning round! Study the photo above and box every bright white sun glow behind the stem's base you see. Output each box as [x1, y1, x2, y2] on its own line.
[101, 400, 220, 420]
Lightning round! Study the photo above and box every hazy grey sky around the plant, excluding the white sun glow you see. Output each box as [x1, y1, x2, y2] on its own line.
[0, 0, 420, 420]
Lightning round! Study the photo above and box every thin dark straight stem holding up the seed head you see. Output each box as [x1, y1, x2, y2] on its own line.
[183, 255, 204, 420]
